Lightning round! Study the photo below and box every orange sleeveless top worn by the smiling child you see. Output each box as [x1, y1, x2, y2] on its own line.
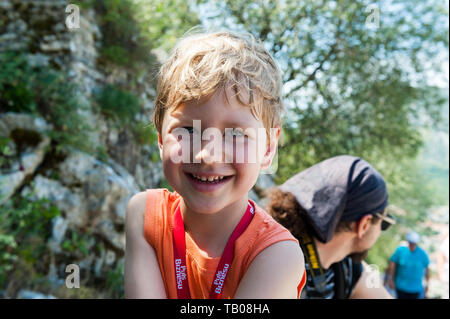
[144, 189, 306, 299]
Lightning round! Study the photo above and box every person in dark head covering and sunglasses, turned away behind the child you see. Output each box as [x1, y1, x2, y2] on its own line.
[267, 155, 395, 299]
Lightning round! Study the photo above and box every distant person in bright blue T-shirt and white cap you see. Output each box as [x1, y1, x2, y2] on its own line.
[388, 231, 430, 299]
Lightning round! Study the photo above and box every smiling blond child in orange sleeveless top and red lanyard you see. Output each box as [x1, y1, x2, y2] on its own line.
[125, 32, 306, 298]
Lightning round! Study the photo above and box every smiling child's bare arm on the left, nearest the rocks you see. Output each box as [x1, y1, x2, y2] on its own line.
[124, 192, 167, 299]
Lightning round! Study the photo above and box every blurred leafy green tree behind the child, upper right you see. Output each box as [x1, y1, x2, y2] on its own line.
[199, 0, 448, 182]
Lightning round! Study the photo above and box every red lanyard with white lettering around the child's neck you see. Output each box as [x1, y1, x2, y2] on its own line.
[173, 202, 255, 299]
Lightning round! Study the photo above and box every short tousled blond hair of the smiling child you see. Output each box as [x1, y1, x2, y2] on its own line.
[153, 31, 283, 133]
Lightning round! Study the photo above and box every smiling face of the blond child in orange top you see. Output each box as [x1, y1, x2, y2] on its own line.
[159, 89, 279, 214]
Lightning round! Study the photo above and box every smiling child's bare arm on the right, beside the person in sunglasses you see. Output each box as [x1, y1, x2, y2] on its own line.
[235, 241, 305, 299]
